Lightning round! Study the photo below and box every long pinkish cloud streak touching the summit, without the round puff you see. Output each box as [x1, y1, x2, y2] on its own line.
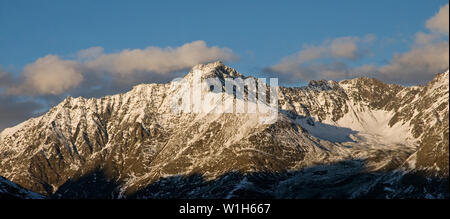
[86, 41, 237, 76]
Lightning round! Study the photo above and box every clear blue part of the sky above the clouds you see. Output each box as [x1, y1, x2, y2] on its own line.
[0, 0, 448, 75]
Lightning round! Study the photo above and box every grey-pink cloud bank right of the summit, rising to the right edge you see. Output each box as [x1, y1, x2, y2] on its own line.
[268, 4, 449, 84]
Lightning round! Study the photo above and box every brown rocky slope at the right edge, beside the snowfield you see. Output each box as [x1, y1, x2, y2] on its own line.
[399, 71, 449, 176]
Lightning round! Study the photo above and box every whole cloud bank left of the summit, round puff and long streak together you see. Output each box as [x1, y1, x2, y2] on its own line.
[7, 41, 238, 95]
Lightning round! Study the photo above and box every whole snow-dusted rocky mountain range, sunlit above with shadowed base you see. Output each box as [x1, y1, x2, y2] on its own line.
[0, 62, 449, 198]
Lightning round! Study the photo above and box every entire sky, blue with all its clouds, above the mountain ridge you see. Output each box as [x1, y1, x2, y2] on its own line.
[0, 0, 449, 130]
